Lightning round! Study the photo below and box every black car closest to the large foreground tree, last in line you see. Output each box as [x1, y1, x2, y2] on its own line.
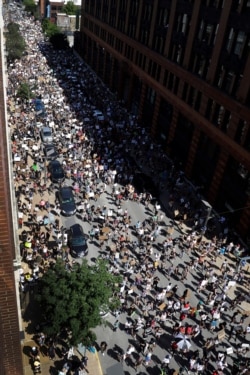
[68, 224, 88, 257]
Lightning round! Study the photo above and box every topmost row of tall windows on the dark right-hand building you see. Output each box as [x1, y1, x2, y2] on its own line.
[83, 0, 250, 72]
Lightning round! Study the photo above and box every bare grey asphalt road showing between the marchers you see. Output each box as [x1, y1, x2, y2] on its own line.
[6, 2, 250, 375]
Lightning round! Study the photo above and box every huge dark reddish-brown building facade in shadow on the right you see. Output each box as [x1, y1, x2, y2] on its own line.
[75, 0, 250, 236]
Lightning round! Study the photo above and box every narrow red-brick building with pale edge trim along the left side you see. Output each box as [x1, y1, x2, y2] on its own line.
[0, 14, 23, 375]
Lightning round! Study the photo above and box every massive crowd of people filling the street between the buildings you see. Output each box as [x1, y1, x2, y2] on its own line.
[4, 3, 250, 375]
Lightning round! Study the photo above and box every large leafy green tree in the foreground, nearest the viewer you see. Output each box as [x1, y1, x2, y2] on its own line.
[37, 260, 121, 346]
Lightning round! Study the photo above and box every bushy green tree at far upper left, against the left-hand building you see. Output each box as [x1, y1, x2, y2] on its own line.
[5, 22, 26, 62]
